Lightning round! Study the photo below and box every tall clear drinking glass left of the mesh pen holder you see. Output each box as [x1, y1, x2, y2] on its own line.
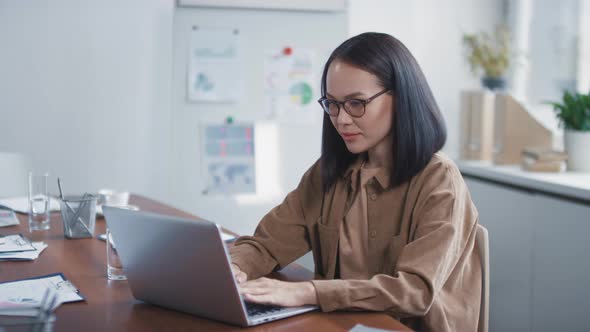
[29, 172, 49, 232]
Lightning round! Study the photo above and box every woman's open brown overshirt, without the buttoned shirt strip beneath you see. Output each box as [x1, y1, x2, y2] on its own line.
[230, 153, 481, 331]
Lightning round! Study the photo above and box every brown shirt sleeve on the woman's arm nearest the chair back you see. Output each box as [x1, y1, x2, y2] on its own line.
[312, 165, 477, 318]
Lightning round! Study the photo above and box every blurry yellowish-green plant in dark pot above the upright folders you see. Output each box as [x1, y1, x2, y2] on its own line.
[463, 26, 510, 90]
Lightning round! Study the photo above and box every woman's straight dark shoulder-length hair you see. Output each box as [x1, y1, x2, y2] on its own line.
[321, 32, 447, 192]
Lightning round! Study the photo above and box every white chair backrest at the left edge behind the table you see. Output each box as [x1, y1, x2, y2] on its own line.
[0, 152, 31, 197]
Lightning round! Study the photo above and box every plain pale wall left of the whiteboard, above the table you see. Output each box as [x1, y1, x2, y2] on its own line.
[0, 0, 174, 202]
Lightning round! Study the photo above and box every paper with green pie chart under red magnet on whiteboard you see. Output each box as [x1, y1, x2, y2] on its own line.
[264, 47, 321, 122]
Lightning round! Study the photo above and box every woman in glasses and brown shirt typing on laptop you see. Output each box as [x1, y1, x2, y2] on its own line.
[230, 33, 481, 331]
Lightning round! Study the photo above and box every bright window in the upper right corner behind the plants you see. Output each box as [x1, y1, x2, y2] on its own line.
[505, 0, 590, 108]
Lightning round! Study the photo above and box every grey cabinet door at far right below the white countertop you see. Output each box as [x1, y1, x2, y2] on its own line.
[533, 195, 590, 331]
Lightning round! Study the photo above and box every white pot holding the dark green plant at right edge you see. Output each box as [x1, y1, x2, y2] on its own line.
[564, 129, 590, 172]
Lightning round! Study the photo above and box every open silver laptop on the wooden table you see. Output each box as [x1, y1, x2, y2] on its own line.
[103, 206, 317, 326]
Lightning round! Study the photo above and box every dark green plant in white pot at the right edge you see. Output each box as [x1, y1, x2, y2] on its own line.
[549, 91, 590, 172]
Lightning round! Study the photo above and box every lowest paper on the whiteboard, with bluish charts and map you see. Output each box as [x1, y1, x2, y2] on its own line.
[201, 123, 256, 195]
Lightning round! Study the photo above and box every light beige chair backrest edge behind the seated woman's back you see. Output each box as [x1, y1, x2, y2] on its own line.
[475, 224, 490, 332]
